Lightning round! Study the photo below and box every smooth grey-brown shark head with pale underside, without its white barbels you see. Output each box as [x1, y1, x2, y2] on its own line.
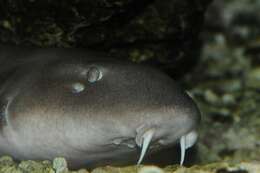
[0, 47, 200, 168]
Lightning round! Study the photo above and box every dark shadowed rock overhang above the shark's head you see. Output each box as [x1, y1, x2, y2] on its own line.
[0, 0, 212, 75]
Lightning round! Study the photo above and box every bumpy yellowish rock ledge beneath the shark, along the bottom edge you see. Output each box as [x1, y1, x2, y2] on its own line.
[0, 157, 260, 173]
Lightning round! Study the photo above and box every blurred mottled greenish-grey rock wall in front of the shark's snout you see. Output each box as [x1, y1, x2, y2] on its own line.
[185, 0, 260, 163]
